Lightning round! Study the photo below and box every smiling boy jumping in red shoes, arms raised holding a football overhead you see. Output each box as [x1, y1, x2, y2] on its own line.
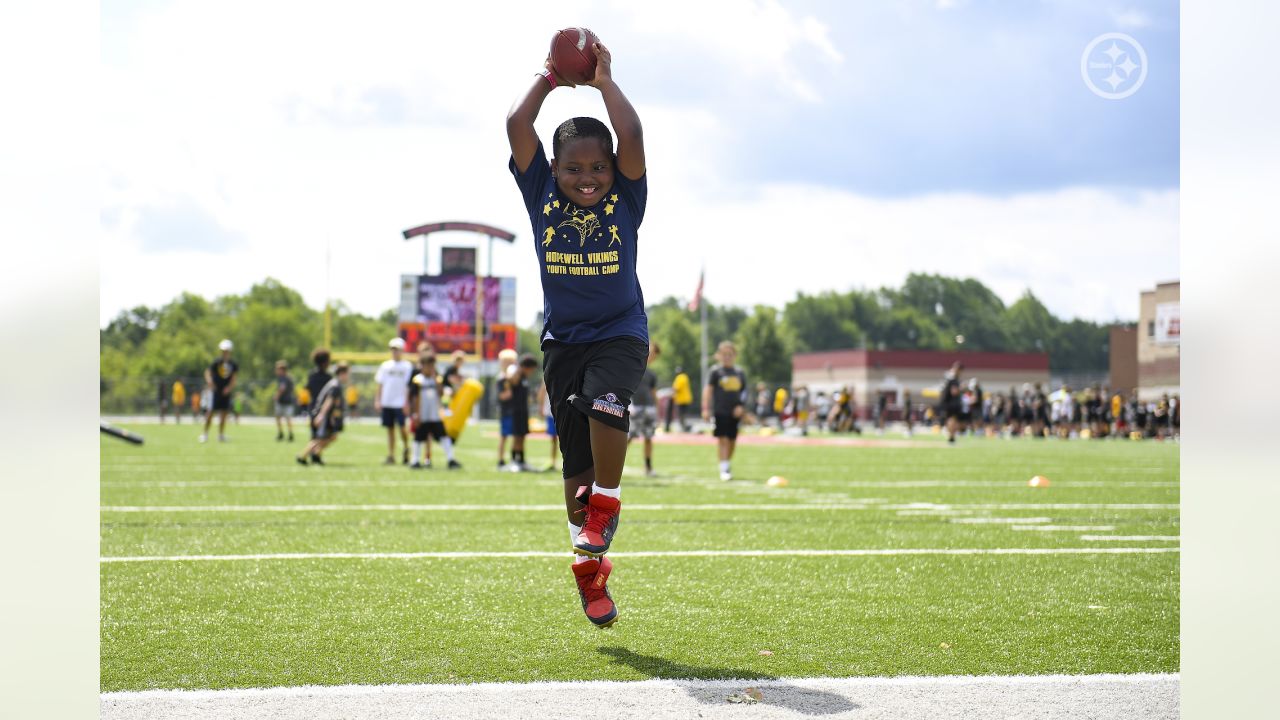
[507, 37, 649, 628]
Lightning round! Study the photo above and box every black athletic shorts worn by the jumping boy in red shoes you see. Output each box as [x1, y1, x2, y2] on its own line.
[543, 337, 649, 478]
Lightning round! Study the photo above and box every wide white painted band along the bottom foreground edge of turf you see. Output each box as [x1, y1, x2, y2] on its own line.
[99, 674, 1180, 720]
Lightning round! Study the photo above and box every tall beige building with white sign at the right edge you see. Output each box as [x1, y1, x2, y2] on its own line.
[1138, 281, 1181, 400]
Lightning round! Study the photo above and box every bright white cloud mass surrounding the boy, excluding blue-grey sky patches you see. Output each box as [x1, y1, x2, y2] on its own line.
[100, 0, 1178, 324]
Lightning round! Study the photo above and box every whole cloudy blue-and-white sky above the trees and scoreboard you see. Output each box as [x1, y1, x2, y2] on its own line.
[100, 0, 1179, 323]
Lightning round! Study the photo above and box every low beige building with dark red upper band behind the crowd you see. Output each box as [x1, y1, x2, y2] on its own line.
[791, 350, 1050, 420]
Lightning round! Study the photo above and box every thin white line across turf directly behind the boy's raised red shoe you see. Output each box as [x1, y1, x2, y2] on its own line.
[99, 547, 1179, 562]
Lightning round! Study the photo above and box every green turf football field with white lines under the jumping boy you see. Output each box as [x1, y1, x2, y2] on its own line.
[101, 424, 1179, 691]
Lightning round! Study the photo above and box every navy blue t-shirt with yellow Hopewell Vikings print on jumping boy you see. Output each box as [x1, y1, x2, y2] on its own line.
[508, 143, 649, 343]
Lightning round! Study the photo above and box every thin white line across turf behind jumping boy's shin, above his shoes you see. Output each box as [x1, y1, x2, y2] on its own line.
[99, 502, 1179, 512]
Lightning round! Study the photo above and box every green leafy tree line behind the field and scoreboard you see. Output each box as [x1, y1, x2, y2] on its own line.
[99, 274, 1108, 411]
